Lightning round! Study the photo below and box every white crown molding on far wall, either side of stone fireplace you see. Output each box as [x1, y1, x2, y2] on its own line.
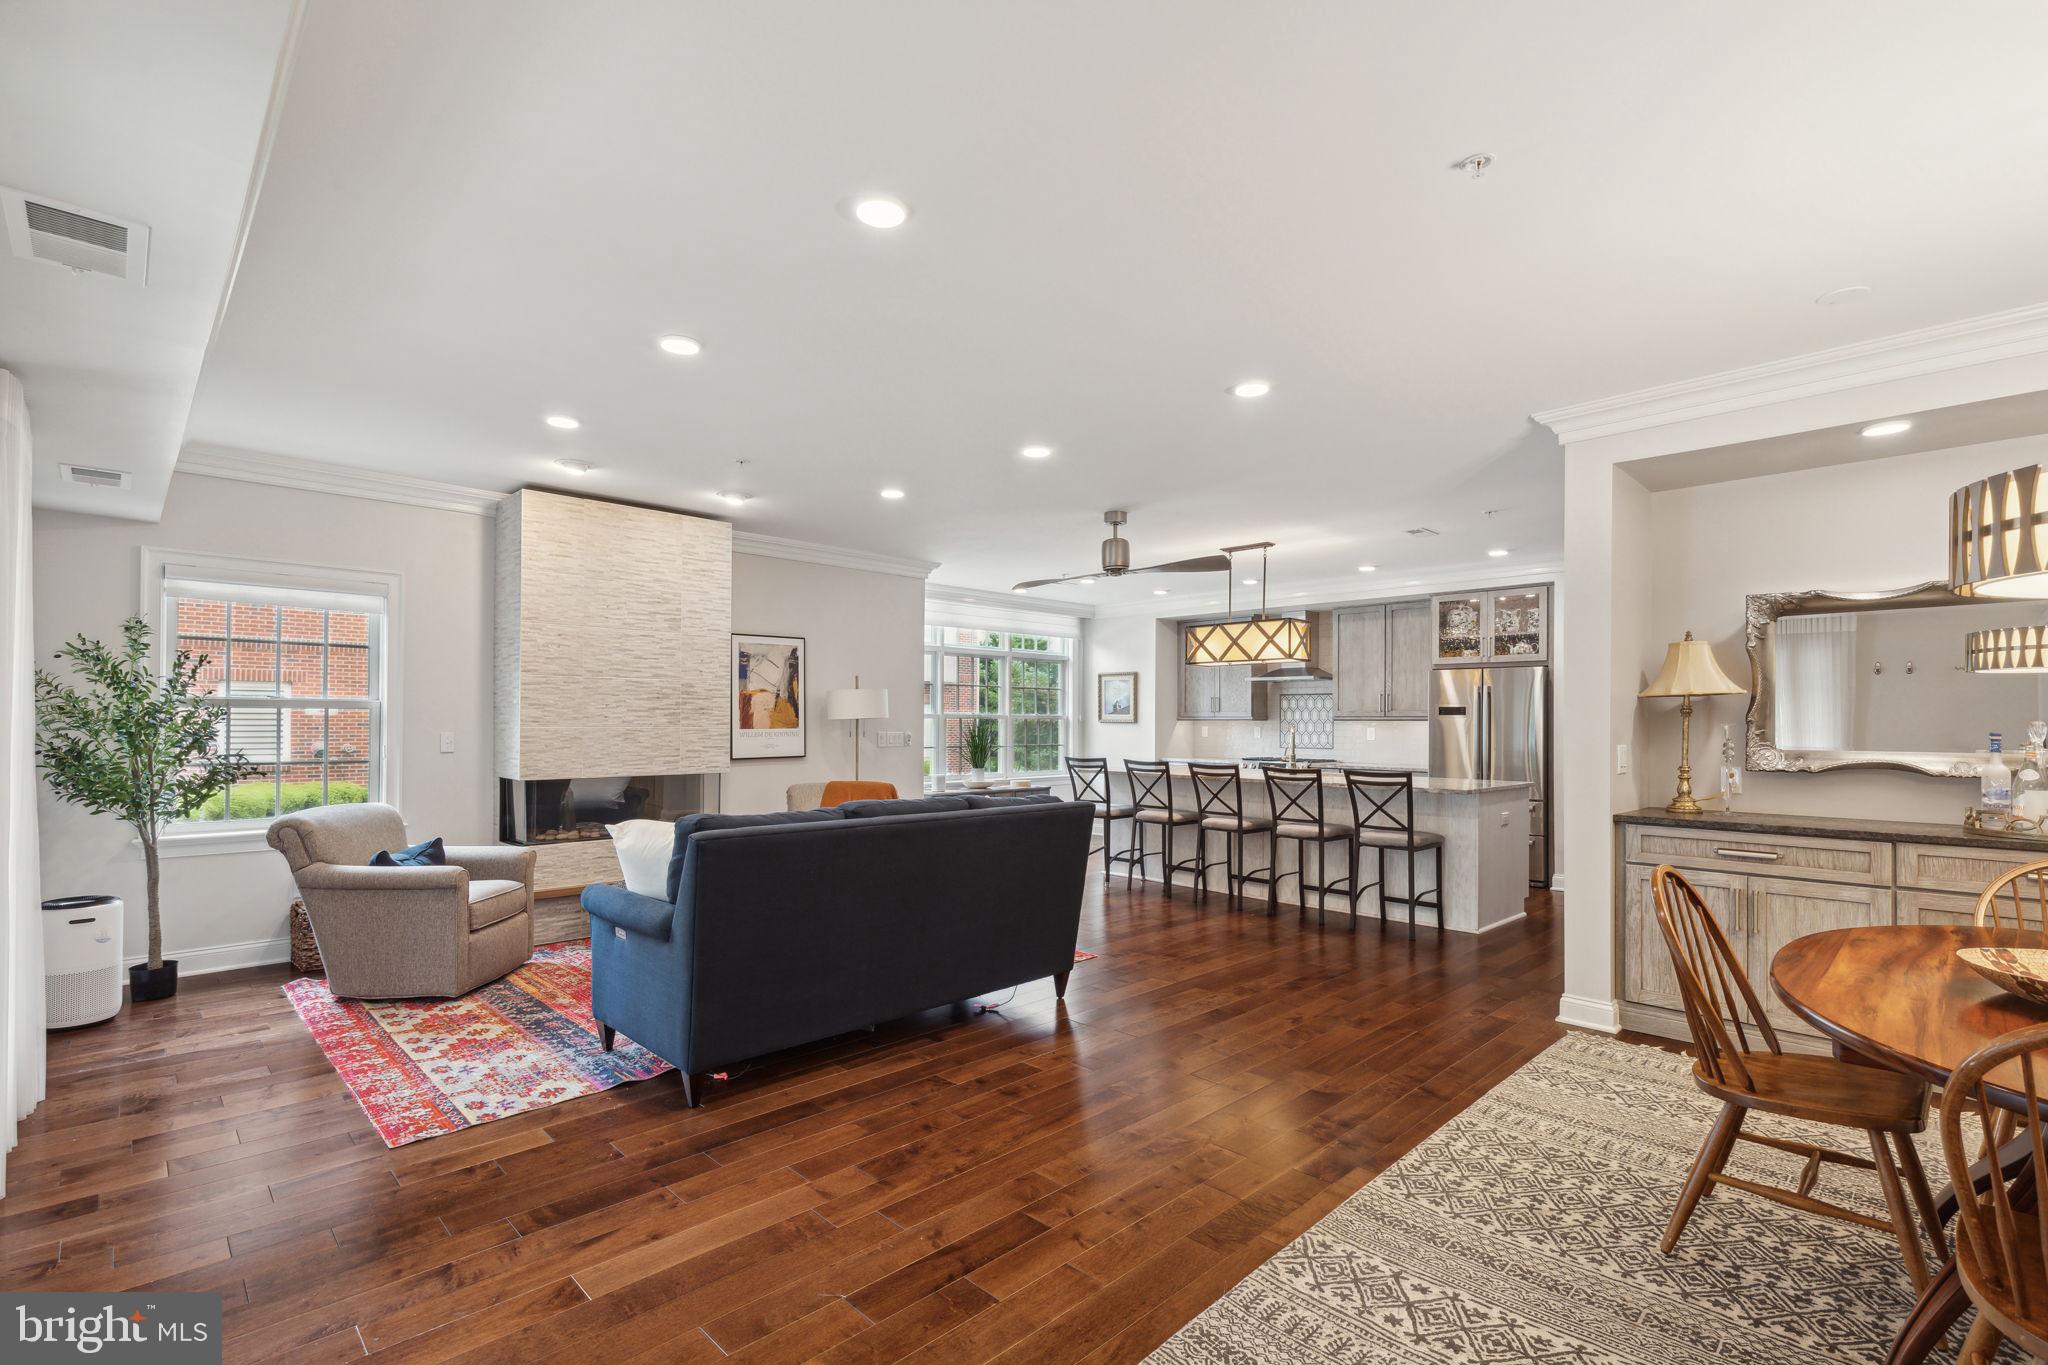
[174, 442, 938, 579]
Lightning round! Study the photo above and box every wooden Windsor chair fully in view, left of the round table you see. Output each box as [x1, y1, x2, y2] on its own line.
[1651, 866, 1942, 1291]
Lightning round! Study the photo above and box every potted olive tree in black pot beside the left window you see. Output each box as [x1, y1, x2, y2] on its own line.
[35, 616, 252, 1001]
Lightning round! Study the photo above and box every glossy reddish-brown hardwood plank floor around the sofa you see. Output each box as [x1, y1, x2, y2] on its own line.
[0, 880, 1563, 1365]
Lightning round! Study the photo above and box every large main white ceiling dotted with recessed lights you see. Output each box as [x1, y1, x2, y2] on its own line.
[132, 0, 2048, 604]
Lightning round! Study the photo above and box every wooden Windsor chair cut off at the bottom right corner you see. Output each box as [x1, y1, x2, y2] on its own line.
[1939, 1023, 2048, 1365]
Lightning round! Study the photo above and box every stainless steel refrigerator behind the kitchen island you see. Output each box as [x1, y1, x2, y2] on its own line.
[1430, 663, 1550, 886]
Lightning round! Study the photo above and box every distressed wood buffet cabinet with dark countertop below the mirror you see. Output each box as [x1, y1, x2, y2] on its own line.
[1614, 808, 2048, 1050]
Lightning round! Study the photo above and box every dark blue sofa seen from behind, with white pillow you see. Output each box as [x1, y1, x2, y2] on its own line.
[584, 796, 1096, 1105]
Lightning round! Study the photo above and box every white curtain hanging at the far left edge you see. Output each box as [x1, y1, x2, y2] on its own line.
[0, 370, 43, 1193]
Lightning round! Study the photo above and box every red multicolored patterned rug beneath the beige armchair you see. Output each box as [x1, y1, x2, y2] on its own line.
[285, 939, 672, 1146]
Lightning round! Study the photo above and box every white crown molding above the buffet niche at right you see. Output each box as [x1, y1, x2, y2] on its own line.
[1532, 303, 2048, 446]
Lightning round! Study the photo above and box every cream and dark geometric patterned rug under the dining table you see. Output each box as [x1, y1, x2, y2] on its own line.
[1149, 1033, 1990, 1365]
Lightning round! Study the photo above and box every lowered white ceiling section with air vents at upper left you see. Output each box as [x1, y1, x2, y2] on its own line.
[0, 0, 291, 518]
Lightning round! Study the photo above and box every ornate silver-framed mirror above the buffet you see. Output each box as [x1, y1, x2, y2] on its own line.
[1743, 581, 2048, 778]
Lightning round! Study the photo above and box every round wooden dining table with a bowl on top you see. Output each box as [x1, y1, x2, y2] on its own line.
[1772, 925, 2048, 1365]
